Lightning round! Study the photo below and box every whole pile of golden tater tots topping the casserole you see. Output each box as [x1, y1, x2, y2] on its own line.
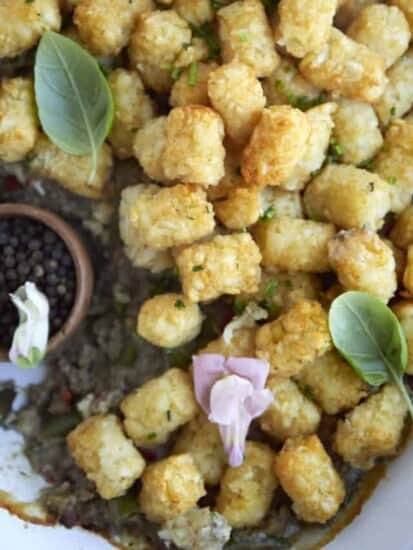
[0, 0, 413, 550]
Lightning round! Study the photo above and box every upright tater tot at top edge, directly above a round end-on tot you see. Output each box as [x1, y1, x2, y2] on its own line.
[217, 0, 280, 78]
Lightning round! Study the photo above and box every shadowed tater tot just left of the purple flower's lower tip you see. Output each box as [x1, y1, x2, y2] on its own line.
[173, 413, 227, 485]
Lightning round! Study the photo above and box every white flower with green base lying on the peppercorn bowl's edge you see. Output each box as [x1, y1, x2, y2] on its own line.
[9, 282, 49, 368]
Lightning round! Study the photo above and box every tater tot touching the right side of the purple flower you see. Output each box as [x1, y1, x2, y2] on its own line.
[259, 378, 321, 441]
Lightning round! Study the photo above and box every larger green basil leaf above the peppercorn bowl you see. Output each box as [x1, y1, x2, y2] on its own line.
[34, 31, 114, 179]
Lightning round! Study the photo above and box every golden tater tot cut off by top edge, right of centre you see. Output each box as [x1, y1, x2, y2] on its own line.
[276, 0, 337, 57]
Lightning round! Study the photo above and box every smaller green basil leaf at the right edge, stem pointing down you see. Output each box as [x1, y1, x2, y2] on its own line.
[329, 292, 413, 418]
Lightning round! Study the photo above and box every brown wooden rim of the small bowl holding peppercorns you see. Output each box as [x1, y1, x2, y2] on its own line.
[0, 203, 93, 360]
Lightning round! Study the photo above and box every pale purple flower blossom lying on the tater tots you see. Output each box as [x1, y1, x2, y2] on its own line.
[193, 353, 273, 467]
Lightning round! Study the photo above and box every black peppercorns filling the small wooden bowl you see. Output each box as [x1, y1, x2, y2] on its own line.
[0, 216, 76, 349]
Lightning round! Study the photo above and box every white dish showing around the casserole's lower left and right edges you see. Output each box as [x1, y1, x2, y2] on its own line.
[0, 363, 413, 550]
